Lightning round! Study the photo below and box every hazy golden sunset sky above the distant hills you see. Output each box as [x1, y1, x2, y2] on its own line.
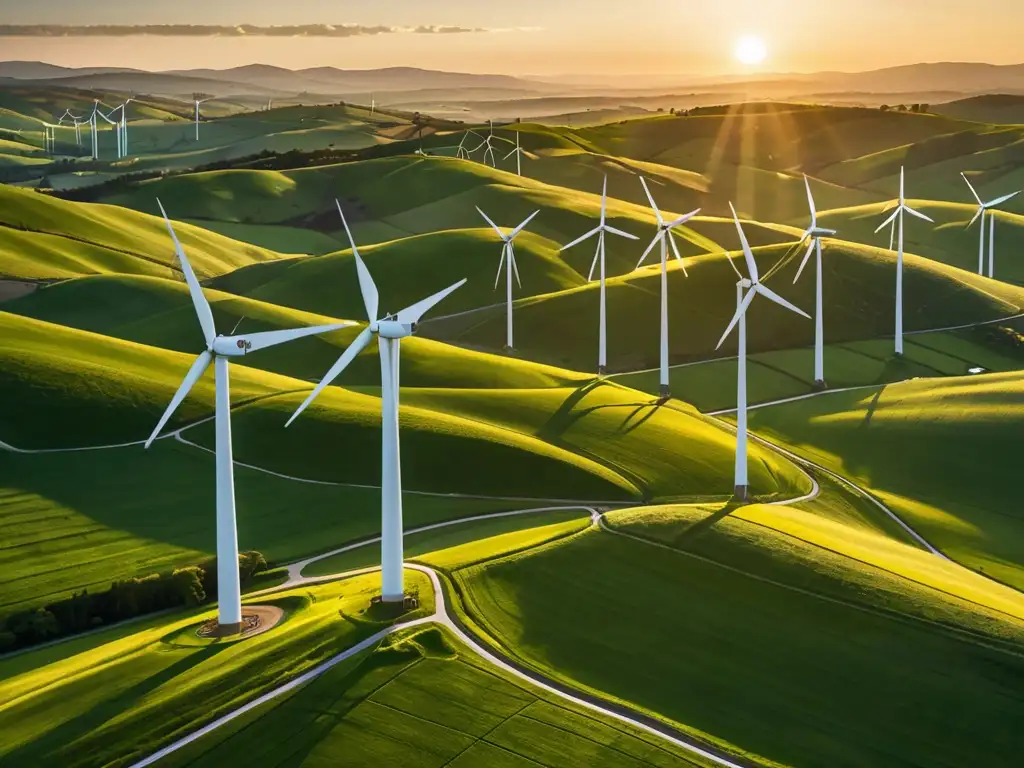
[0, 0, 1024, 76]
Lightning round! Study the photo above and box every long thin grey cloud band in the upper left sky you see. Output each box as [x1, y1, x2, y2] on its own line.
[0, 24, 489, 38]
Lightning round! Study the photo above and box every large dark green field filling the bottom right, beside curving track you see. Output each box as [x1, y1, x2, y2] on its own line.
[454, 513, 1024, 766]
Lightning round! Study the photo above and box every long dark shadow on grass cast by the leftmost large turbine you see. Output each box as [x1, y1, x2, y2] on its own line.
[0, 645, 228, 766]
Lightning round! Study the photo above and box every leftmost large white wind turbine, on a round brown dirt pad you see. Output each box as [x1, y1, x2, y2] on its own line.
[145, 200, 352, 635]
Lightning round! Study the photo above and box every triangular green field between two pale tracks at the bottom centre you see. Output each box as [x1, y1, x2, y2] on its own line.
[166, 629, 720, 768]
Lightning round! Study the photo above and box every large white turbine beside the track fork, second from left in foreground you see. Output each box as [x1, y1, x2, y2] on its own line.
[286, 201, 466, 602]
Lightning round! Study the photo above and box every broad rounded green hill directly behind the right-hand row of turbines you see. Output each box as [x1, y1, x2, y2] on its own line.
[423, 240, 1024, 371]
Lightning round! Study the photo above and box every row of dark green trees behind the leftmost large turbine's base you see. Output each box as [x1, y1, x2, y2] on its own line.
[0, 552, 267, 652]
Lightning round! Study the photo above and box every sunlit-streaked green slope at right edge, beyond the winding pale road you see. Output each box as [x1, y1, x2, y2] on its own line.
[751, 372, 1024, 588]
